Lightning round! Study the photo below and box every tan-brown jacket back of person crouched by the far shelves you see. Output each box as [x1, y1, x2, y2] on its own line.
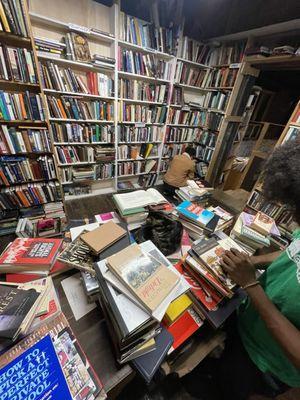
[164, 153, 195, 187]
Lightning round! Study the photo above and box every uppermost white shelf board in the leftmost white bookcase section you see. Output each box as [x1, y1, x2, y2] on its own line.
[29, 12, 115, 44]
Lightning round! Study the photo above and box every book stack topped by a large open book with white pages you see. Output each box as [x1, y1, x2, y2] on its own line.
[113, 188, 168, 230]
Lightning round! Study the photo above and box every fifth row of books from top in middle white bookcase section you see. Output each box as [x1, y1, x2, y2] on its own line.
[118, 125, 163, 143]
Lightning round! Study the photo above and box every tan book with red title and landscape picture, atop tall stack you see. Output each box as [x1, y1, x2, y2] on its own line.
[107, 244, 179, 314]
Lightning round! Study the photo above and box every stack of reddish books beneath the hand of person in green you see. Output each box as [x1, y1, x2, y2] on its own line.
[180, 232, 249, 328]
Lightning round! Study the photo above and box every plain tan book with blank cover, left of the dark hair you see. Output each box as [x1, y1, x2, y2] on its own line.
[81, 221, 126, 255]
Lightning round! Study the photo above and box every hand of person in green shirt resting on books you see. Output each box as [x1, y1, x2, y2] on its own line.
[220, 249, 256, 286]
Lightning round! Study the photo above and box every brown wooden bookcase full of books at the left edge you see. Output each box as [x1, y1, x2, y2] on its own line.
[0, 0, 62, 216]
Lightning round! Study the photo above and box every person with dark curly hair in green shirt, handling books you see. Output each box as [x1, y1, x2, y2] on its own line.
[218, 142, 300, 400]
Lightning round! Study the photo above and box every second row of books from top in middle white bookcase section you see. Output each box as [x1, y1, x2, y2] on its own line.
[118, 47, 171, 80]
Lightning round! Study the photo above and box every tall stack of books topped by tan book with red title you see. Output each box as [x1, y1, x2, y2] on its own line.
[95, 241, 189, 369]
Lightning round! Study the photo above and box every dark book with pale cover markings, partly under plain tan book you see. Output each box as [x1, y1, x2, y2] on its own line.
[57, 231, 96, 275]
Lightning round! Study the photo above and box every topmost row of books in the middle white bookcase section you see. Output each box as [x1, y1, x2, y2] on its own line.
[119, 12, 178, 54]
